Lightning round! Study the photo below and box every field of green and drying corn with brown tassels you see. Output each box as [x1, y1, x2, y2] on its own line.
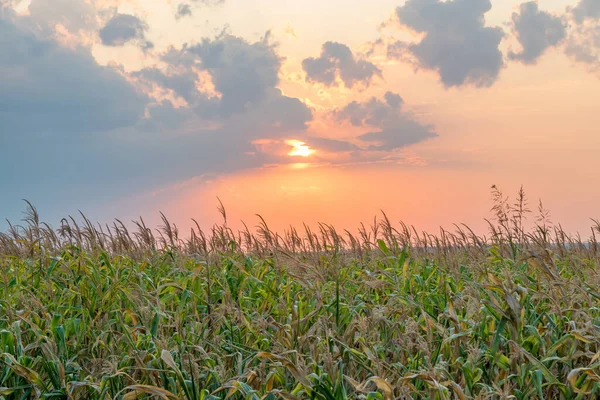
[0, 193, 600, 400]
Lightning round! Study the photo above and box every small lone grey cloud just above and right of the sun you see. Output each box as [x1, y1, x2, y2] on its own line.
[302, 42, 382, 88]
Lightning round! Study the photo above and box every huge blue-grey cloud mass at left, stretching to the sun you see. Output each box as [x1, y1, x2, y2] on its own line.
[0, 10, 312, 222]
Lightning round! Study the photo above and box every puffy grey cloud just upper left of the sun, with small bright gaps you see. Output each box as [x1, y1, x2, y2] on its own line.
[136, 35, 312, 128]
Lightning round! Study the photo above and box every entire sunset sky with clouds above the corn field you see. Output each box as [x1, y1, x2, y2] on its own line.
[0, 0, 600, 235]
